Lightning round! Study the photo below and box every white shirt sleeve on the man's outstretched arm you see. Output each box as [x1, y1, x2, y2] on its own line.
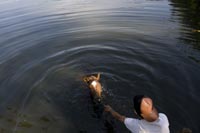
[124, 118, 138, 133]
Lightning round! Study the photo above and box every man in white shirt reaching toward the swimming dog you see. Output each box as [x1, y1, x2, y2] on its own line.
[105, 95, 169, 133]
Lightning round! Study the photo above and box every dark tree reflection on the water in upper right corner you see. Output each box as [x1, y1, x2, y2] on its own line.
[171, 0, 200, 62]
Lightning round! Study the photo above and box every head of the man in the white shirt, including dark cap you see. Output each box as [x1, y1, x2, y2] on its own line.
[133, 95, 158, 122]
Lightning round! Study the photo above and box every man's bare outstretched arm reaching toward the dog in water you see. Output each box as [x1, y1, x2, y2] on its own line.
[105, 105, 126, 122]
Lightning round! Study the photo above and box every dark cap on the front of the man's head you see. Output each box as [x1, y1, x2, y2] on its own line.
[133, 95, 145, 118]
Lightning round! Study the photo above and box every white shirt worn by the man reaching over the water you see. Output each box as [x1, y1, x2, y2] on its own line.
[124, 113, 169, 133]
